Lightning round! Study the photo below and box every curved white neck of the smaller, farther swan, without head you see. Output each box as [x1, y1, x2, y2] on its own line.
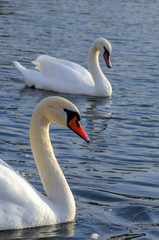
[88, 43, 112, 96]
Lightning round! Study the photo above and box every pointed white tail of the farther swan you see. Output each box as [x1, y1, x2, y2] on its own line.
[14, 61, 38, 88]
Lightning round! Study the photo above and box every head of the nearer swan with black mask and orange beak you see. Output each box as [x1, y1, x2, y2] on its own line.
[37, 97, 89, 142]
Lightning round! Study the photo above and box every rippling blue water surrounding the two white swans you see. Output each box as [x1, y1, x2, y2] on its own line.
[0, 0, 159, 240]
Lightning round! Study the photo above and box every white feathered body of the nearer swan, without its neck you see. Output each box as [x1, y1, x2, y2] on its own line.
[0, 160, 54, 230]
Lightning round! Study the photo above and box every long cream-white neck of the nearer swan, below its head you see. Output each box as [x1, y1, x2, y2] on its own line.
[30, 107, 75, 218]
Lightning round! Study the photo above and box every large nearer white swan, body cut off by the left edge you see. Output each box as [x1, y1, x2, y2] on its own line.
[0, 97, 89, 230]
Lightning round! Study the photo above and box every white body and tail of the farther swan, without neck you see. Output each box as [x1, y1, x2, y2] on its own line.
[14, 58, 94, 94]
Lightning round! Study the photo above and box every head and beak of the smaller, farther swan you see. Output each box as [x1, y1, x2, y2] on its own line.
[94, 38, 112, 68]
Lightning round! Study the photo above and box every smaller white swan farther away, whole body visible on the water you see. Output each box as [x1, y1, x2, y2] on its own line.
[14, 38, 112, 97]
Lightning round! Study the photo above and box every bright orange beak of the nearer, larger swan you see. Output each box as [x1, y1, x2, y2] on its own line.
[68, 117, 89, 142]
